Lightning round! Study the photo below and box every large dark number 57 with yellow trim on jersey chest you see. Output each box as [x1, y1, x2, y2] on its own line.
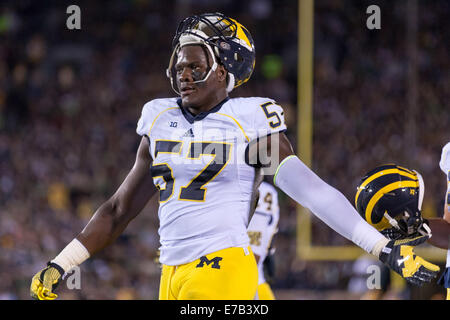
[151, 140, 231, 202]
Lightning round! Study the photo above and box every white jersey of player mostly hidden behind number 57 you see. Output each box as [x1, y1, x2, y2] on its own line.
[247, 181, 280, 284]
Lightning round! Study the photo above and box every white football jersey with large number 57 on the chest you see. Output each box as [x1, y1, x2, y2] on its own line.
[136, 98, 286, 265]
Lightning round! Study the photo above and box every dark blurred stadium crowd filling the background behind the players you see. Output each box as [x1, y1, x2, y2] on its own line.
[0, 0, 450, 299]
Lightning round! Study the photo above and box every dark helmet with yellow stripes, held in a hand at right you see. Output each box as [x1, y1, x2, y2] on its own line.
[355, 164, 431, 240]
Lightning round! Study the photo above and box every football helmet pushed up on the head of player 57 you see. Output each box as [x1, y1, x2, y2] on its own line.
[166, 12, 255, 94]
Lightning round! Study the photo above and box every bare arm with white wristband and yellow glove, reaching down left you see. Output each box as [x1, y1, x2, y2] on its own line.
[30, 137, 157, 300]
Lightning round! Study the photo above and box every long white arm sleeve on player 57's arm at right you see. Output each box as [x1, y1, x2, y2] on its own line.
[274, 156, 386, 253]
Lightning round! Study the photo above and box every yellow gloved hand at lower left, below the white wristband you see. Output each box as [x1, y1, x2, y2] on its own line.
[30, 262, 64, 300]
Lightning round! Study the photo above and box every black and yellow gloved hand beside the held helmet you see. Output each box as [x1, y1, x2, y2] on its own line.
[379, 236, 439, 285]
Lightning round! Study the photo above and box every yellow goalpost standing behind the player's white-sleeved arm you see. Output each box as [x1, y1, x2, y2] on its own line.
[296, 0, 446, 262]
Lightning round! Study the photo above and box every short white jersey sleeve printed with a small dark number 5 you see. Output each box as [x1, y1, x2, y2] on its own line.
[251, 98, 287, 140]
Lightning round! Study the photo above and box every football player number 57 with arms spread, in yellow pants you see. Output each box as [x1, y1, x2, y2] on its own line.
[30, 13, 439, 299]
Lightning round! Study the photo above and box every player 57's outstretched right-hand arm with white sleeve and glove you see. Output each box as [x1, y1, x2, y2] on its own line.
[249, 133, 439, 284]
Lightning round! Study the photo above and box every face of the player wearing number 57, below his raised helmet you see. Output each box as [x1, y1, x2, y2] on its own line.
[175, 45, 225, 111]
